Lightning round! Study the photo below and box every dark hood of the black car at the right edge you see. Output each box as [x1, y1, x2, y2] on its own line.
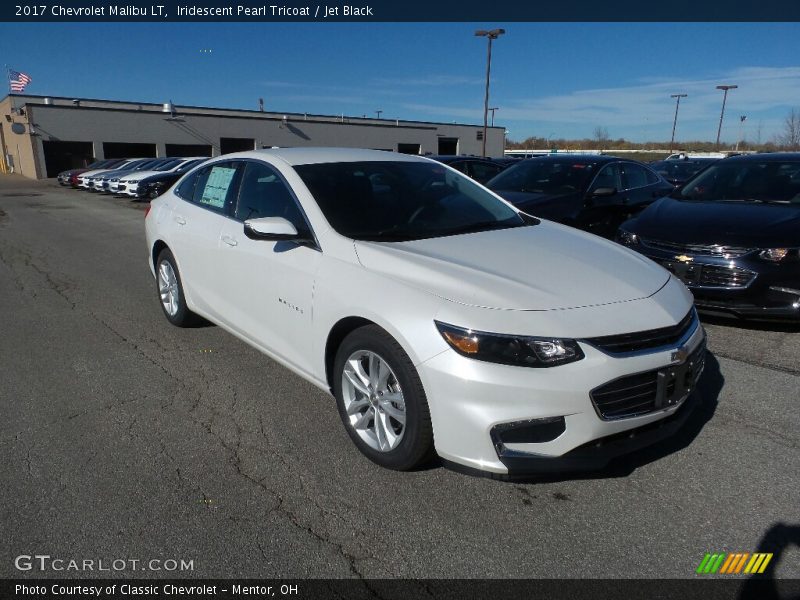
[632, 198, 800, 248]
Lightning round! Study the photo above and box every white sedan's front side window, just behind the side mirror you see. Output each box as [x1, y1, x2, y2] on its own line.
[236, 162, 308, 231]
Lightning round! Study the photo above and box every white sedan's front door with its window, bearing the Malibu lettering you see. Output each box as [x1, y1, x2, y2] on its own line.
[220, 160, 322, 372]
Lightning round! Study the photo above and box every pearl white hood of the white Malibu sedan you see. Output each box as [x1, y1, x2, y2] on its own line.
[355, 221, 669, 310]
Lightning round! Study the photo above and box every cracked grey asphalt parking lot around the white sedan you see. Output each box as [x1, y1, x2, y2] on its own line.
[0, 176, 800, 578]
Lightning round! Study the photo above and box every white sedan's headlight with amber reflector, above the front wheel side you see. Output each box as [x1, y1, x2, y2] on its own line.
[434, 321, 584, 367]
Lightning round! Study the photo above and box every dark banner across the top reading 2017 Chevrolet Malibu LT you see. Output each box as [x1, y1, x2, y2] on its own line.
[0, 0, 800, 23]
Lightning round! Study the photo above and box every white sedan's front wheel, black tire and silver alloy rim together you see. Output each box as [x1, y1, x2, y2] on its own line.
[333, 325, 433, 471]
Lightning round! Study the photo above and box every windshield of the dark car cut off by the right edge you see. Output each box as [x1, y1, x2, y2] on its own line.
[673, 160, 800, 204]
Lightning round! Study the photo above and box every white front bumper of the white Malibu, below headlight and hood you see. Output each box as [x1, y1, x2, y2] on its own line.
[418, 316, 705, 475]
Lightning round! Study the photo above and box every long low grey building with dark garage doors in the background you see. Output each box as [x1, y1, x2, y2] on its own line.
[0, 94, 505, 179]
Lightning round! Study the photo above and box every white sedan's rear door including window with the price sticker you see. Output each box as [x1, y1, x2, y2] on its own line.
[168, 161, 239, 318]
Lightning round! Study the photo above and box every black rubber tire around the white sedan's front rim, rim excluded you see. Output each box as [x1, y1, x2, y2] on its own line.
[333, 326, 433, 471]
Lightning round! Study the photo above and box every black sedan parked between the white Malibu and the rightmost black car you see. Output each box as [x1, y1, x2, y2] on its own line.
[486, 155, 674, 237]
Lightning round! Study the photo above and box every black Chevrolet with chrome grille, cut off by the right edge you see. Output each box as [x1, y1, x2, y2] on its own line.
[617, 153, 800, 320]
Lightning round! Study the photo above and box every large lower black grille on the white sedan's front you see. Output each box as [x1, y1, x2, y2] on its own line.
[591, 341, 705, 421]
